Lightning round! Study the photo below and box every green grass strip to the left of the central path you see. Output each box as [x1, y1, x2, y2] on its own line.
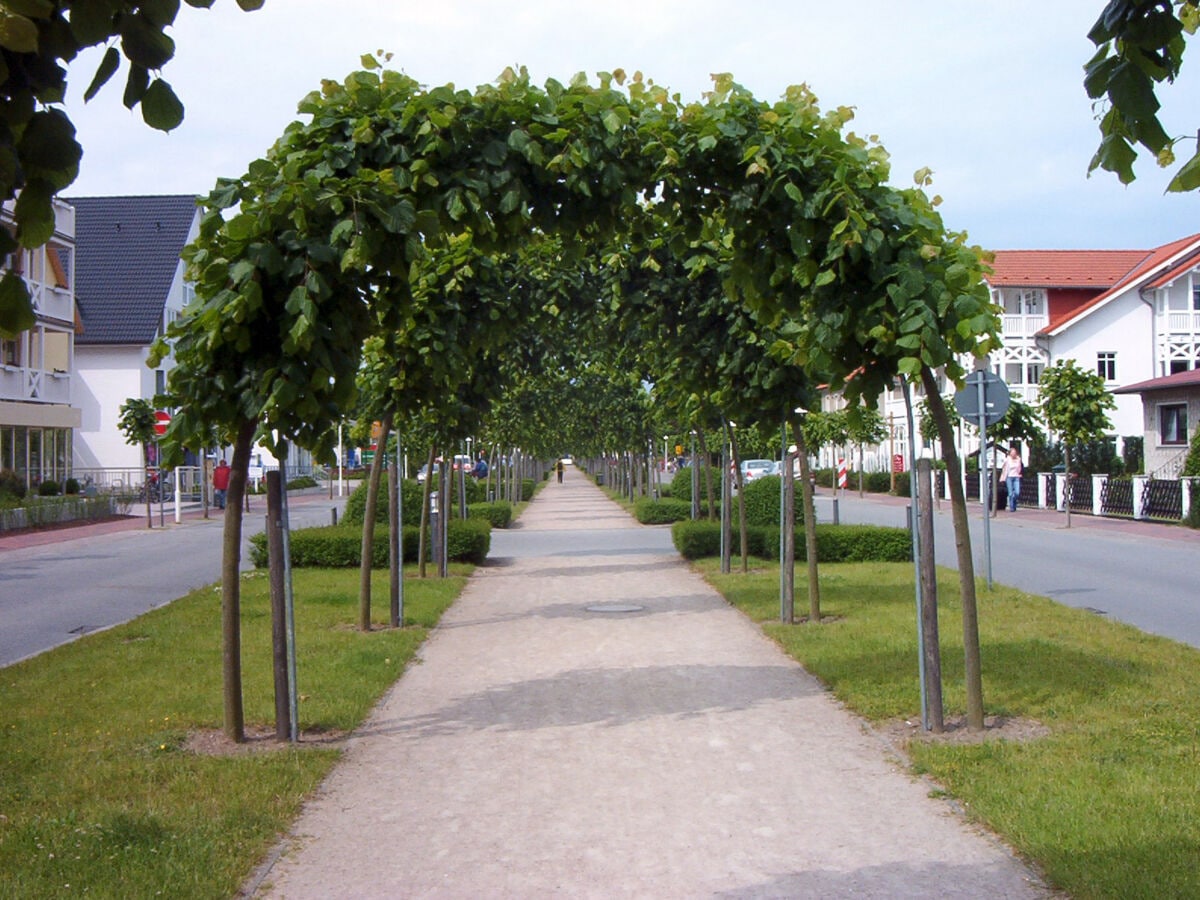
[0, 565, 470, 898]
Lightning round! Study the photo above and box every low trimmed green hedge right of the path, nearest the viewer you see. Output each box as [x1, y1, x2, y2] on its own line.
[671, 520, 912, 563]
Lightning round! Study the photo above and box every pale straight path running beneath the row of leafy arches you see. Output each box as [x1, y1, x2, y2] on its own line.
[254, 468, 1049, 899]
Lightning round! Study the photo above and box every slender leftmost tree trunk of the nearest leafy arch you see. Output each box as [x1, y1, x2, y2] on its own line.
[221, 420, 258, 744]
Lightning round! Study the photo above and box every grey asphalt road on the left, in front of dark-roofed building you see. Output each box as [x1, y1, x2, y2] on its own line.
[0, 494, 344, 666]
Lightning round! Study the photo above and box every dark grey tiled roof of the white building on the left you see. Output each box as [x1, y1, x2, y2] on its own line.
[67, 194, 197, 344]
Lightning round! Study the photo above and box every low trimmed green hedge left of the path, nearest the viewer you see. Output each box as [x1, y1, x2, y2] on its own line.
[250, 518, 492, 569]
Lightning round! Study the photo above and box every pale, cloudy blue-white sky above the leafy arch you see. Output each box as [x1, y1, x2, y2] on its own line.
[67, 0, 1200, 250]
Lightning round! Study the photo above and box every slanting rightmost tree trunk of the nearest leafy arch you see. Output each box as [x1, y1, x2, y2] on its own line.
[920, 366, 984, 731]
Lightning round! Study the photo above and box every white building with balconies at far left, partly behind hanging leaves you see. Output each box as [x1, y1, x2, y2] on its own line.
[0, 202, 80, 488]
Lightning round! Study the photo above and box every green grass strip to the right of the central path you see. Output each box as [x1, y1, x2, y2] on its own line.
[695, 560, 1200, 900]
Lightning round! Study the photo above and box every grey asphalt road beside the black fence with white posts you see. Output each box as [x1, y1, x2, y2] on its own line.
[816, 491, 1200, 647]
